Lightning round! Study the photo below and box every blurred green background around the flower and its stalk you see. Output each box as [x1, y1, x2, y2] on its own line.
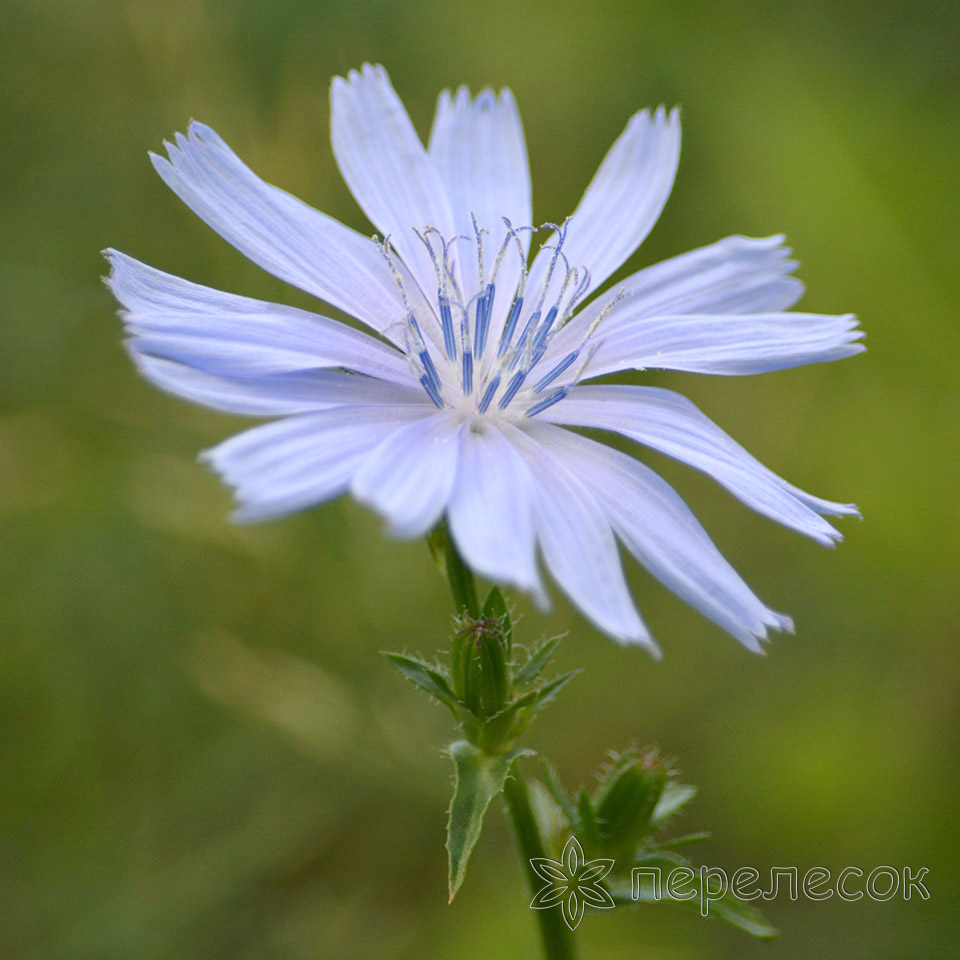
[0, 0, 960, 960]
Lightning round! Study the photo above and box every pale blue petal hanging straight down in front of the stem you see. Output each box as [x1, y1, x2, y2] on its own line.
[447, 423, 545, 602]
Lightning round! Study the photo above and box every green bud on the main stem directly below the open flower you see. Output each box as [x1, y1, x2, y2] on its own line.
[450, 619, 511, 719]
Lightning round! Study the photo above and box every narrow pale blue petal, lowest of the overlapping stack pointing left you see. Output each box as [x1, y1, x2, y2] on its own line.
[130, 347, 434, 417]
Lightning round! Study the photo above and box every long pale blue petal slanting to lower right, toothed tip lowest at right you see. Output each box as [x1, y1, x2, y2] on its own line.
[529, 423, 793, 653]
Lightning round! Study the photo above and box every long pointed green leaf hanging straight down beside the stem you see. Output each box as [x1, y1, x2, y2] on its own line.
[447, 740, 535, 900]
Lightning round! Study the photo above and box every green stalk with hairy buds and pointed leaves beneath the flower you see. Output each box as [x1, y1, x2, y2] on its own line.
[384, 524, 776, 960]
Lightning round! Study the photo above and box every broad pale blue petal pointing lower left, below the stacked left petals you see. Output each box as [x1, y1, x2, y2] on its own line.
[202, 404, 433, 521]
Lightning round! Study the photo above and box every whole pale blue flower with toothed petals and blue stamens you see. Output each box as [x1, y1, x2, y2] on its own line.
[108, 66, 863, 651]
